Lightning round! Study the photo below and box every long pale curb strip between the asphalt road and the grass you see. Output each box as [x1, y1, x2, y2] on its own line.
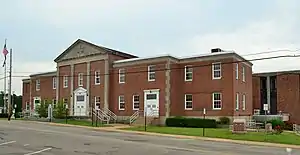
[17, 121, 300, 149]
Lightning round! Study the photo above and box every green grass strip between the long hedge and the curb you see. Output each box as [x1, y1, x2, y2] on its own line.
[123, 126, 300, 145]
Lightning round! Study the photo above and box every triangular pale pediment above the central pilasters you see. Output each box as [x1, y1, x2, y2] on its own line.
[54, 39, 107, 62]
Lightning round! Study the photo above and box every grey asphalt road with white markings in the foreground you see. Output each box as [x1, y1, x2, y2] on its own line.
[0, 120, 300, 155]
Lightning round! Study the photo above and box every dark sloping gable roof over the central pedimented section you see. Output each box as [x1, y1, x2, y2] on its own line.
[54, 39, 137, 62]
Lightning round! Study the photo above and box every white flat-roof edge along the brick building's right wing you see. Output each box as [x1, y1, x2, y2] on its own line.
[114, 51, 253, 65]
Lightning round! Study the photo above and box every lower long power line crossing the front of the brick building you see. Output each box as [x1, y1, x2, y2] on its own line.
[2, 55, 300, 80]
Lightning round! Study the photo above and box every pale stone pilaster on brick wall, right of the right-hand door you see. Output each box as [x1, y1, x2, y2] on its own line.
[165, 60, 171, 117]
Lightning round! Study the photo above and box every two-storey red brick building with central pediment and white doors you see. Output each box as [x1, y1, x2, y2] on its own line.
[23, 39, 253, 123]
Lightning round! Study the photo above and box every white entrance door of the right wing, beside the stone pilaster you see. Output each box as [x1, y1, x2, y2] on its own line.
[144, 90, 159, 116]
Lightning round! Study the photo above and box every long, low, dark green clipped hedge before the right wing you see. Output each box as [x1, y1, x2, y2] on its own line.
[166, 117, 217, 128]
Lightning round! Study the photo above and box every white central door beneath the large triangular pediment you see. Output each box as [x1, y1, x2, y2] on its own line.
[74, 94, 86, 116]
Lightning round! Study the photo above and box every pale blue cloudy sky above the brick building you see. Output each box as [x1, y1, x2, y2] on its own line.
[0, 0, 300, 94]
